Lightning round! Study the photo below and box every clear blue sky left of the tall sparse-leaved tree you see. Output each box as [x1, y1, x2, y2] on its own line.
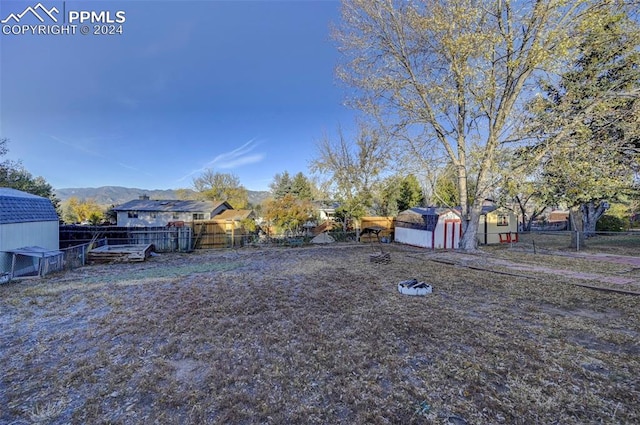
[0, 0, 353, 190]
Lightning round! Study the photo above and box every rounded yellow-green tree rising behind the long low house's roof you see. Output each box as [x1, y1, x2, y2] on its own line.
[193, 170, 249, 209]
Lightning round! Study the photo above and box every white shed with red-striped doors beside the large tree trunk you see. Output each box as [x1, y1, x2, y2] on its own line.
[395, 207, 462, 249]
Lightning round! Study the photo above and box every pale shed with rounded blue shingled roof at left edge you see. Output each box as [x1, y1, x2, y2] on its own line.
[0, 187, 59, 274]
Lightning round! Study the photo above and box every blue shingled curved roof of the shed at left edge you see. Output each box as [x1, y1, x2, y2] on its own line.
[0, 187, 59, 224]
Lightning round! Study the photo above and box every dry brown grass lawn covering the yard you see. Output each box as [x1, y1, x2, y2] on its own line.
[0, 244, 640, 425]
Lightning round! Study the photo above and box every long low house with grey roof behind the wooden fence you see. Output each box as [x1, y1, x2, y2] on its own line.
[113, 196, 233, 227]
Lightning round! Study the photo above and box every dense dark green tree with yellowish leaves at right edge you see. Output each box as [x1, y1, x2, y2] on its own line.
[530, 9, 640, 240]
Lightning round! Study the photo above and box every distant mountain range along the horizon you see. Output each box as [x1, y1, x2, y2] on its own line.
[55, 186, 271, 206]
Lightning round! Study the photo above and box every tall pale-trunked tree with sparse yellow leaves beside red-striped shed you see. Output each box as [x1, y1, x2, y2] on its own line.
[336, 0, 610, 250]
